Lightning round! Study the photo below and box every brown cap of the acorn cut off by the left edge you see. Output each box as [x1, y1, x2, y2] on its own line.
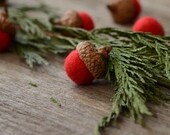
[0, 13, 16, 35]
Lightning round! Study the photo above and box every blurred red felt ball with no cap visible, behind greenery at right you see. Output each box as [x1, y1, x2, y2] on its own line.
[132, 16, 164, 36]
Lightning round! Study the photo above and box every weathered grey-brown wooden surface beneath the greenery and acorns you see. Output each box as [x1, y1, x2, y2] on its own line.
[0, 0, 170, 135]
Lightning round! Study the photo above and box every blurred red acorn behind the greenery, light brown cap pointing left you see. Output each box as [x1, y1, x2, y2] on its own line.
[54, 10, 95, 30]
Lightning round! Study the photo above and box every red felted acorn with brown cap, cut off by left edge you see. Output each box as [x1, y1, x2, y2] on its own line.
[0, 13, 15, 52]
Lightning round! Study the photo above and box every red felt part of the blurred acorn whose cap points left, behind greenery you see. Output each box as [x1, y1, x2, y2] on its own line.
[78, 12, 94, 30]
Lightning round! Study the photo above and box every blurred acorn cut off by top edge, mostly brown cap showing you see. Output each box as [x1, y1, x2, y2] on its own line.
[107, 0, 141, 24]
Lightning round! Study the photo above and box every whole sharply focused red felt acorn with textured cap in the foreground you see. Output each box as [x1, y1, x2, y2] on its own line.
[64, 41, 112, 85]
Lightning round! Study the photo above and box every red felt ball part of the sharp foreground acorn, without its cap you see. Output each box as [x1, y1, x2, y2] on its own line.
[64, 50, 94, 85]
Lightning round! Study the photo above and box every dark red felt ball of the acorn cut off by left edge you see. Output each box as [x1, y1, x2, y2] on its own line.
[0, 30, 12, 52]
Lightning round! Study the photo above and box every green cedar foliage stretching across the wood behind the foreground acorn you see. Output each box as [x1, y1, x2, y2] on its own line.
[4, 5, 170, 135]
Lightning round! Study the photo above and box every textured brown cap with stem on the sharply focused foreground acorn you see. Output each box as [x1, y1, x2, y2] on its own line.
[76, 41, 112, 79]
